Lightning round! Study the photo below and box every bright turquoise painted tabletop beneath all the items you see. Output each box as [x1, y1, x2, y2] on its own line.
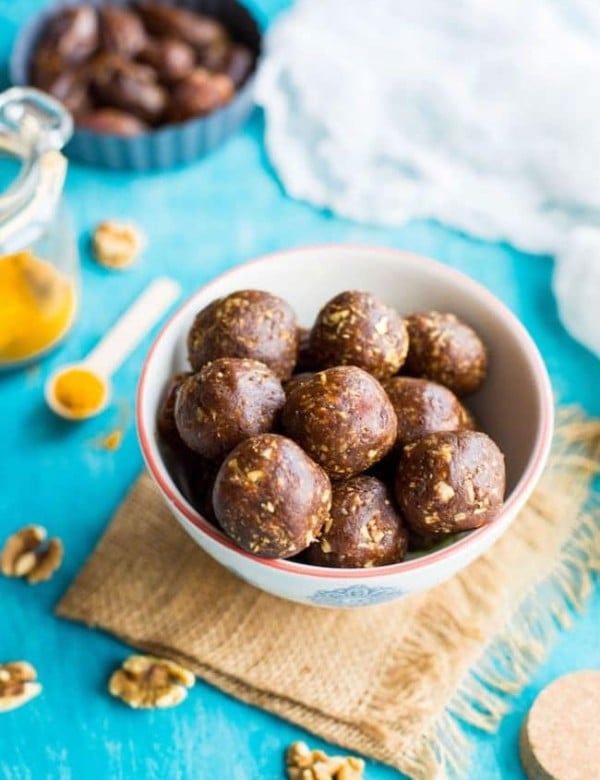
[0, 0, 600, 780]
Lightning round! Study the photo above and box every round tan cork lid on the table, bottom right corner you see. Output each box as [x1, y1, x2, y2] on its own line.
[520, 670, 600, 780]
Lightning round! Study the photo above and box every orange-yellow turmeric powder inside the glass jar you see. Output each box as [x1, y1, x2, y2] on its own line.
[0, 252, 76, 365]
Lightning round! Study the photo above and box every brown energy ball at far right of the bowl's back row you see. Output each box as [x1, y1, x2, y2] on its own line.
[405, 311, 487, 396]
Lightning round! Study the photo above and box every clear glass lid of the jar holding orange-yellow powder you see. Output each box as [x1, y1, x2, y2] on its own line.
[0, 87, 73, 253]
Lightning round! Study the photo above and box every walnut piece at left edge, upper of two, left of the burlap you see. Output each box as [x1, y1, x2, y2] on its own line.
[0, 525, 64, 585]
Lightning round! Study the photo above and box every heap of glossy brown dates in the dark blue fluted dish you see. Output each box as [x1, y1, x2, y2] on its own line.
[30, 0, 256, 136]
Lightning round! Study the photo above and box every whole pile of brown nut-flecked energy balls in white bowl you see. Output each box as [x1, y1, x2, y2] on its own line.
[157, 290, 505, 568]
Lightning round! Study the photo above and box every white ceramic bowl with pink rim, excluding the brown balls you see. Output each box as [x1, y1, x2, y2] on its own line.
[137, 245, 553, 607]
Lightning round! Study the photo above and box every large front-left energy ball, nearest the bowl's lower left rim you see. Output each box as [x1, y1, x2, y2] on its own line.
[213, 433, 331, 558]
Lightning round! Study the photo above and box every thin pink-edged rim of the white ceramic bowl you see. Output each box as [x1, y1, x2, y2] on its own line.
[136, 244, 554, 580]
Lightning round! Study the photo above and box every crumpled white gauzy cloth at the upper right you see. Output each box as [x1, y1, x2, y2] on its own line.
[257, 0, 600, 354]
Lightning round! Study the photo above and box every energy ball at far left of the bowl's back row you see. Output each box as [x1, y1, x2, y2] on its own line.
[188, 290, 298, 379]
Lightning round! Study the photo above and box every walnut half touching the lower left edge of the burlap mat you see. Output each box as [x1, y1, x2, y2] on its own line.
[108, 655, 196, 709]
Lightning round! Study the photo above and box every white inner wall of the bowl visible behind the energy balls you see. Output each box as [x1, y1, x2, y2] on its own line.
[139, 245, 551, 556]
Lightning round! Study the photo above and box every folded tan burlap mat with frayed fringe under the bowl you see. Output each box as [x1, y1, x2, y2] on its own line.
[58, 411, 600, 780]
